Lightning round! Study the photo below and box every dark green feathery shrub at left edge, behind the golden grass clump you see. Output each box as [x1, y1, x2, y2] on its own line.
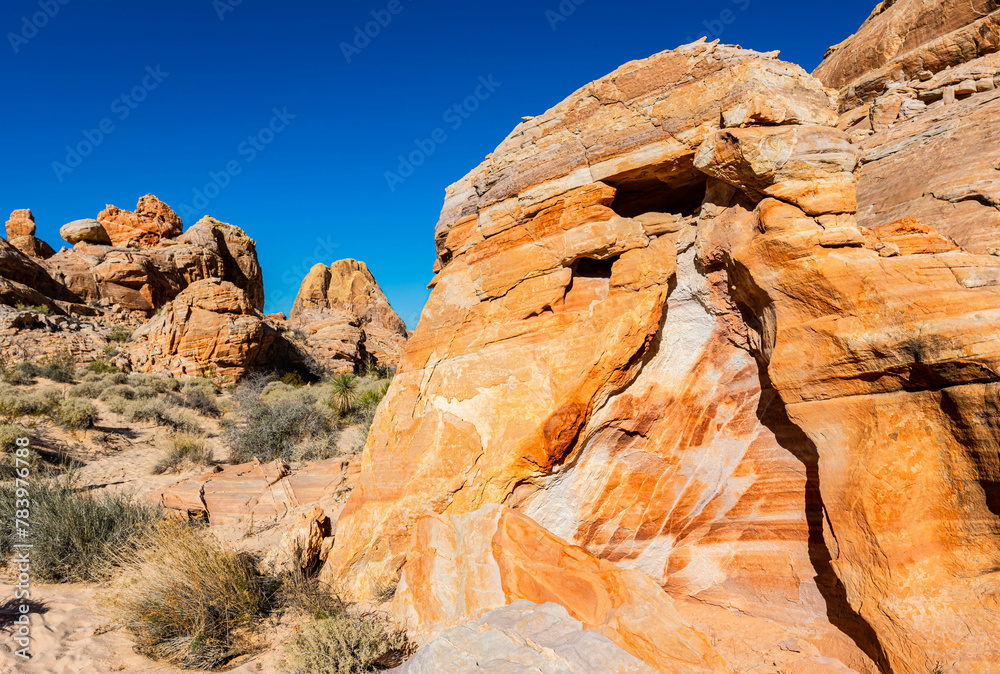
[0, 477, 162, 583]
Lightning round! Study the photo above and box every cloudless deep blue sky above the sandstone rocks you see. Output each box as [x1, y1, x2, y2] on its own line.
[0, 0, 875, 328]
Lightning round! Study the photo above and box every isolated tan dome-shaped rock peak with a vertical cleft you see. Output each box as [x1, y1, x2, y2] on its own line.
[289, 260, 407, 372]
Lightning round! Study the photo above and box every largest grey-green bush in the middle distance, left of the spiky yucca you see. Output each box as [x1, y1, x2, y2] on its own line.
[222, 377, 335, 463]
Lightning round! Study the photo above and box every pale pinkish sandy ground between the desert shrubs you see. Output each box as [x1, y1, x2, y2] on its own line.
[0, 383, 360, 674]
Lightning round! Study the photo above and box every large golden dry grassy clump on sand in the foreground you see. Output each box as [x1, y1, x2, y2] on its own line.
[115, 524, 271, 669]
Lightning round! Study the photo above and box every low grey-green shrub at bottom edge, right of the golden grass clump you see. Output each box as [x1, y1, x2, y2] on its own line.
[287, 610, 413, 674]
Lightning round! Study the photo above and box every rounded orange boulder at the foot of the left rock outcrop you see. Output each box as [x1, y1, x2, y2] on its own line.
[129, 279, 283, 383]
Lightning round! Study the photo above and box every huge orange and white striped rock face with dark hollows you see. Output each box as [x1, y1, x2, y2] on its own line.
[324, 44, 1000, 672]
